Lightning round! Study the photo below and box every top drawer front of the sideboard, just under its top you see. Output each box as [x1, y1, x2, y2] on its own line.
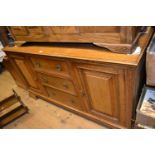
[31, 58, 69, 75]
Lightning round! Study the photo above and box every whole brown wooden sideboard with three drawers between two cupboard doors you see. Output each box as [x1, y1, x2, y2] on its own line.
[3, 28, 153, 128]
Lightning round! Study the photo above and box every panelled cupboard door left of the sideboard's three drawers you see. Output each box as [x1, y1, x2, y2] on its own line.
[10, 55, 41, 92]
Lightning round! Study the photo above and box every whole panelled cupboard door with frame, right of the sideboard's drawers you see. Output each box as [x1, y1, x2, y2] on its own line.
[77, 65, 124, 125]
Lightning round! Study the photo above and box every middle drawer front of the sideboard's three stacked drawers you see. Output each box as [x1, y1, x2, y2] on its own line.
[38, 73, 76, 95]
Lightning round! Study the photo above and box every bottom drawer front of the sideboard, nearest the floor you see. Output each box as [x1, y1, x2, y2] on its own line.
[45, 87, 82, 110]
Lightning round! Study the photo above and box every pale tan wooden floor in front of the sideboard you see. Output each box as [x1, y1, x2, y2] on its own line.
[0, 71, 106, 129]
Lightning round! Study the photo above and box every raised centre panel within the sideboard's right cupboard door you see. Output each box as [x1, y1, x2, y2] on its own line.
[83, 71, 119, 120]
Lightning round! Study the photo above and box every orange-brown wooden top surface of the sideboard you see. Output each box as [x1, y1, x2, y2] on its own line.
[3, 43, 144, 66]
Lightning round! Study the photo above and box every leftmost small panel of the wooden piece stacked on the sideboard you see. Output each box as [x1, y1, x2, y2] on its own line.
[11, 26, 28, 36]
